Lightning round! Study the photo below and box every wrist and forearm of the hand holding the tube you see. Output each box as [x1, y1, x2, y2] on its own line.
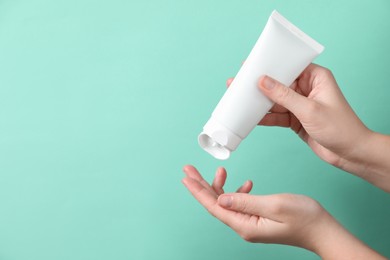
[340, 131, 390, 192]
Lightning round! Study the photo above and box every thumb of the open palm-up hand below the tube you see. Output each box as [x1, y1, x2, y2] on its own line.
[218, 193, 286, 221]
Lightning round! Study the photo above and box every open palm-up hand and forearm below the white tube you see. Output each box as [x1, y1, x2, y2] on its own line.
[183, 165, 382, 259]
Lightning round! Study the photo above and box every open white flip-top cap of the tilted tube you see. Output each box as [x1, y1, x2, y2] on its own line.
[198, 118, 242, 160]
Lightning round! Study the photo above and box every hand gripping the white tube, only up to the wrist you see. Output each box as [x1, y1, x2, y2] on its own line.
[259, 64, 370, 164]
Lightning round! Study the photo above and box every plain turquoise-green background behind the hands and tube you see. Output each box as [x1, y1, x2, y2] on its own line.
[0, 0, 390, 260]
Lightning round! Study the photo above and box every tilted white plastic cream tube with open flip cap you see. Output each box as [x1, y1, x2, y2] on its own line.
[198, 11, 324, 160]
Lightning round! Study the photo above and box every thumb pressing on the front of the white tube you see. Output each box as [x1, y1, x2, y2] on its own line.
[258, 76, 313, 119]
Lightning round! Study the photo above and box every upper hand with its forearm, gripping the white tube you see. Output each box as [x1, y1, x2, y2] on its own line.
[227, 64, 390, 191]
